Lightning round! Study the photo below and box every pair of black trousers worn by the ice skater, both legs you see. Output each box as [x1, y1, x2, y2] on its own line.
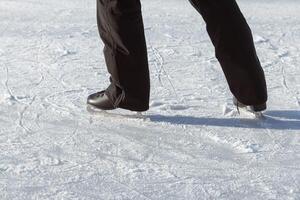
[97, 0, 267, 110]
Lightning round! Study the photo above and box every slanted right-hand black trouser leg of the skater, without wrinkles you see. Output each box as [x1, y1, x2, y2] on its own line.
[189, 0, 267, 105]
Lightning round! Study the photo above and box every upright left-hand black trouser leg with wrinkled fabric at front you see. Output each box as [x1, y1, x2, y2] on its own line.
[97, 0, 150, 110]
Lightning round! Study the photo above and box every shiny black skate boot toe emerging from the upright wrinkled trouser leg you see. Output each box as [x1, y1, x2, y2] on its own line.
[87, 90, 116, 110]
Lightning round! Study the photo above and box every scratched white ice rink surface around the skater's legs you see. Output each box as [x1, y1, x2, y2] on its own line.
[0, 0, 300, 200]
